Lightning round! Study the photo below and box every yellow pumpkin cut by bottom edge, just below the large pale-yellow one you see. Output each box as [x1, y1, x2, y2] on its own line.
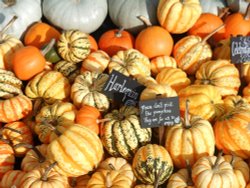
[19, 163, 69, 188]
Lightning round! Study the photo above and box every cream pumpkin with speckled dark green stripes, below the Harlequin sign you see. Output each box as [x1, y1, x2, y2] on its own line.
[100, 106, 152, 159]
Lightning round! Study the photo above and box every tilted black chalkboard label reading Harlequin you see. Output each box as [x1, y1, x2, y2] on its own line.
[103, 70, 145, 106]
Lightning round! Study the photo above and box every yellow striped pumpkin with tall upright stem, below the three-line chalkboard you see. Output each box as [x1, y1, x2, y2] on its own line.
[165, 101, 215, 168]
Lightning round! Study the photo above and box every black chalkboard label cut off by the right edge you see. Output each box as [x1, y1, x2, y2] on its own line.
[231, 36, 250, 64]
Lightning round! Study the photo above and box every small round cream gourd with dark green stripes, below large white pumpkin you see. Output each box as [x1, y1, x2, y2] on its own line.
[57, 30, 90, 63]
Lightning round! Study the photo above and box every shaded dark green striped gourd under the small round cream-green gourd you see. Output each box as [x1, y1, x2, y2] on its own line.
[54, 60, 80, 83]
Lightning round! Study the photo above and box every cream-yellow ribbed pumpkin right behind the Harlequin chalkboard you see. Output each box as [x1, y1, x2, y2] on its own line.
[108, 49, 151, 77]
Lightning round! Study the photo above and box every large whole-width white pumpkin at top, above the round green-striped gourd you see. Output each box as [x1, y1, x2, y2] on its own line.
[43, 0, 108, 33]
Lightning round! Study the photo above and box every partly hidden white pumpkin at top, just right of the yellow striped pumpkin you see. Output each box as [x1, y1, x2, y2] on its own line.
[200, 0, 226, 16]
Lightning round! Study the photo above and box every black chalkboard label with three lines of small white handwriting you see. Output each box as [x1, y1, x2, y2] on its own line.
[139, 97, 180, 128]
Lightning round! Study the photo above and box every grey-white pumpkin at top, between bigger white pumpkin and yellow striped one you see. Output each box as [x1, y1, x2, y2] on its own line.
[108, 0, 159, 33]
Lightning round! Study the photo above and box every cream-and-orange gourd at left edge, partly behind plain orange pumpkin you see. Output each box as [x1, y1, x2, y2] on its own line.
[0, 34, 23, 70]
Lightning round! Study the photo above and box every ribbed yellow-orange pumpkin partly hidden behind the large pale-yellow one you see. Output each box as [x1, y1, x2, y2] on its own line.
[34, 102, 76, 144]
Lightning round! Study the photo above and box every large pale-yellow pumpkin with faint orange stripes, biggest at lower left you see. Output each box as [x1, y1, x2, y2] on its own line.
[47, 124, 104, 177]
